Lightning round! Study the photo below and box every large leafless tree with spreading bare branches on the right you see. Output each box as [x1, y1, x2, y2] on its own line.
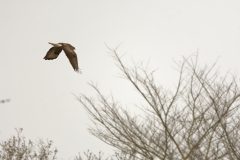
[78, 46, 240, 160]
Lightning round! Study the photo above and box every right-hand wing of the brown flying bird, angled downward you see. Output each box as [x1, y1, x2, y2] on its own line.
[62, 43, 81, 73]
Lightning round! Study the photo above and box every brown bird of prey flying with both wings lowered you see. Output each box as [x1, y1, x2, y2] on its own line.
[43, 42, 82, 73]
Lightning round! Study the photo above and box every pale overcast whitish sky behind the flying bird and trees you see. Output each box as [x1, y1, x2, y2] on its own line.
[0, 0, 240, 159]
